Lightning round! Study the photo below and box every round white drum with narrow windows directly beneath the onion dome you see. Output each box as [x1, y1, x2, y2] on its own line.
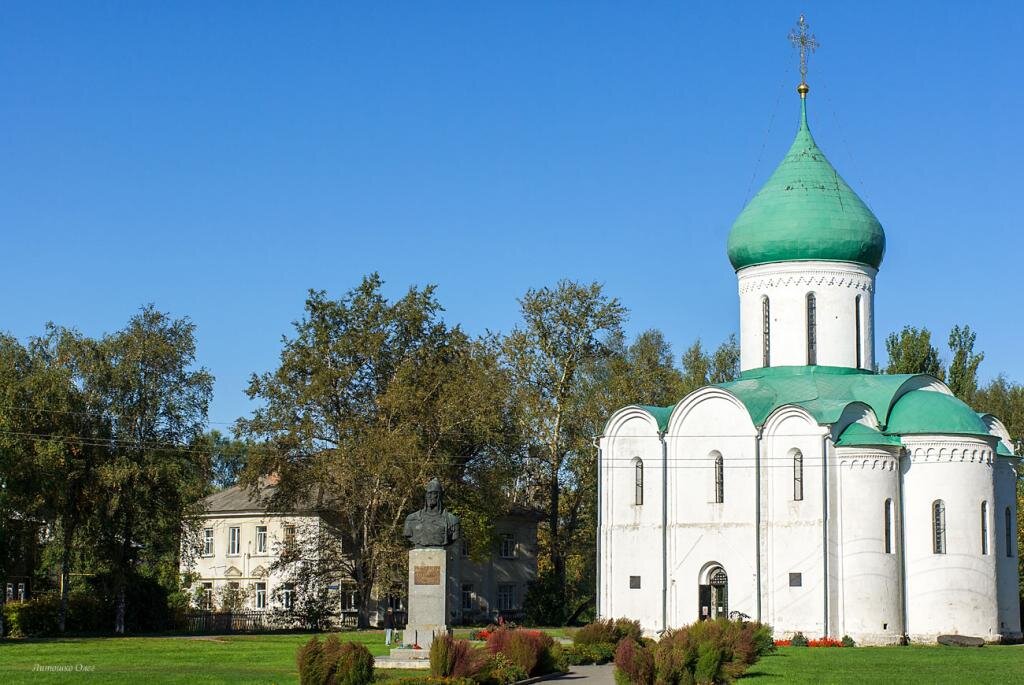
[736, 261, 878, 371]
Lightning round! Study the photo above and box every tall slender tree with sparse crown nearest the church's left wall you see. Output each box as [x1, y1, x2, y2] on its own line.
[505, 281, 622, 619]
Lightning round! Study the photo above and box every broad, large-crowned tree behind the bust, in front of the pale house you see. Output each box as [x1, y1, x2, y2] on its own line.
[236, 273, 512, 626]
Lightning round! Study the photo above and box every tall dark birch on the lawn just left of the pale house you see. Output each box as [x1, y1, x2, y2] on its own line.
[75, 305, 213, 634]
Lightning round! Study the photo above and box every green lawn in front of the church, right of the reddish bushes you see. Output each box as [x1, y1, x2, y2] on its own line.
[743, 645, 1024, 685]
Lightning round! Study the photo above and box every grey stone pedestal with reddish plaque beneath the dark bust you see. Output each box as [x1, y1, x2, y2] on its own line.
[402, 546, 459, 650]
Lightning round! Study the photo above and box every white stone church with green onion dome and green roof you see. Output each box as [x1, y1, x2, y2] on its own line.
[598, 84, 1021, 644]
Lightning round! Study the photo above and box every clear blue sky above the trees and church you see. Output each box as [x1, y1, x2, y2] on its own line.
[0, 0, 1024, 427]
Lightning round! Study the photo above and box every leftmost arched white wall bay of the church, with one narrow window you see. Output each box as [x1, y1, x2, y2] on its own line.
[598, 408, 664, 633]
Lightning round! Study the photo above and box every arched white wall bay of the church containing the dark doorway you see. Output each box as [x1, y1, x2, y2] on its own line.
[666, 387, 757, 628]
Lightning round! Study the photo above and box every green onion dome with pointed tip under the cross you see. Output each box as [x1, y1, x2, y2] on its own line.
[728, 99, 886, 270]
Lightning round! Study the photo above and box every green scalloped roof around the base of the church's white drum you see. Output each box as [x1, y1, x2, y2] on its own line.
[719, 367, 931, 426]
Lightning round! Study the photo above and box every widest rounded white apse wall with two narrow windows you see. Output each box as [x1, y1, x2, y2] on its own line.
[901, 435, 999, 642]
